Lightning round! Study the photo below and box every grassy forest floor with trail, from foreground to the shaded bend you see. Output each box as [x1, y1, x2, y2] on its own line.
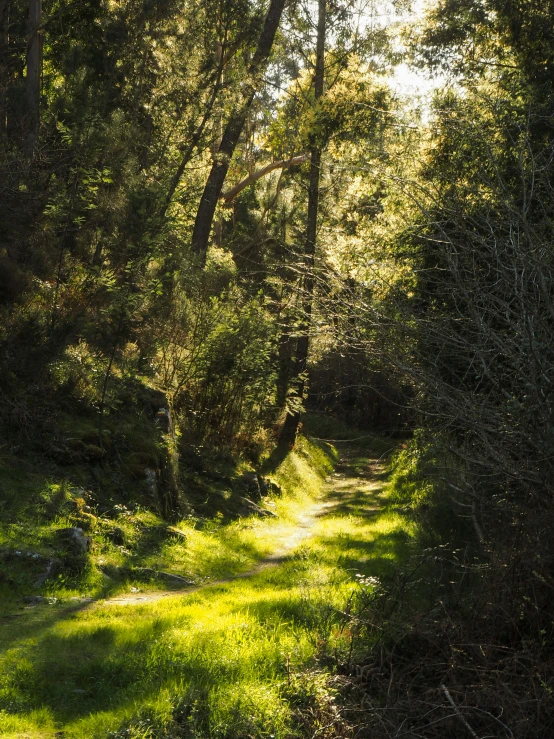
[0, 443, 416, 739]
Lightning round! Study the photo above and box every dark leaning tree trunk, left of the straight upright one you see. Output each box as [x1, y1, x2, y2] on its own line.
[192, 0, 286, 265]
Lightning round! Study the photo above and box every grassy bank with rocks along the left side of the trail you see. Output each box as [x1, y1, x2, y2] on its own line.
[0, 439, 333, 614]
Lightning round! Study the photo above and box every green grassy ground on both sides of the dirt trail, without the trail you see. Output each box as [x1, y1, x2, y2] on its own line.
[0, 430, 417, 739]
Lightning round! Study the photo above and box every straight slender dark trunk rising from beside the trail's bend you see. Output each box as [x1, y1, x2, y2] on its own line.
[279, 0, 327, 446]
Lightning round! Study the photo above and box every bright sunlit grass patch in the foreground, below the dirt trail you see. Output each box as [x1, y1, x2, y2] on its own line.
[0, 557, 350, 737]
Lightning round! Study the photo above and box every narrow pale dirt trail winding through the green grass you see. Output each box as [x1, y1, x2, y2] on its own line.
[101, 449, 385, 606]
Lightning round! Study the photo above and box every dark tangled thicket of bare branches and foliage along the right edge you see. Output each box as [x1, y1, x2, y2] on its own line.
[320, 0, 554, 737]
